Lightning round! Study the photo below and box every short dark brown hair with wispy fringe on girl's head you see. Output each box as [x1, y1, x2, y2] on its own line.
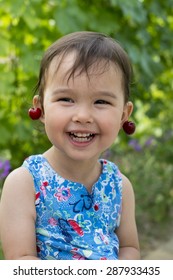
[35, 31, 132, 102]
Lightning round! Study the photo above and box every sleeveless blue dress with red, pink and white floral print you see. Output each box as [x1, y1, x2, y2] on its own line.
[23, 154, 122, 260]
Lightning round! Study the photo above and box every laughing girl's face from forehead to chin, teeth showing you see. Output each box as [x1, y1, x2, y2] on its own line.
[38, 53, 132, 161]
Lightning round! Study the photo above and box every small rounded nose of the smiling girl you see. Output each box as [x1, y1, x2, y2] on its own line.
[72, 106, 93, 123]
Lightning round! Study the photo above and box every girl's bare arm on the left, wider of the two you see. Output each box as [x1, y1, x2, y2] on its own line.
[0, 167, 38, 260]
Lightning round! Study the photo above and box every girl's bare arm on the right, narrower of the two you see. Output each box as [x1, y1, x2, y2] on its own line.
[116, 176, 140, 260]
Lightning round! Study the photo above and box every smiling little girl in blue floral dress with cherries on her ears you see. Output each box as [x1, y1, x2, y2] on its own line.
[0, 32, 140, 260]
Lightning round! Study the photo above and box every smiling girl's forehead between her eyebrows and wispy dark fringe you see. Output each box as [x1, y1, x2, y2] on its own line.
[45, 53, 124, 104]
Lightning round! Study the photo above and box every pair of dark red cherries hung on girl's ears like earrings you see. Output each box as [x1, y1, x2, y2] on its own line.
[28, 108, 136, 135]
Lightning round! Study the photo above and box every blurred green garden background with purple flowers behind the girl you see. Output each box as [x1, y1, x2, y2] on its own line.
[0, 0, 173, 259]
